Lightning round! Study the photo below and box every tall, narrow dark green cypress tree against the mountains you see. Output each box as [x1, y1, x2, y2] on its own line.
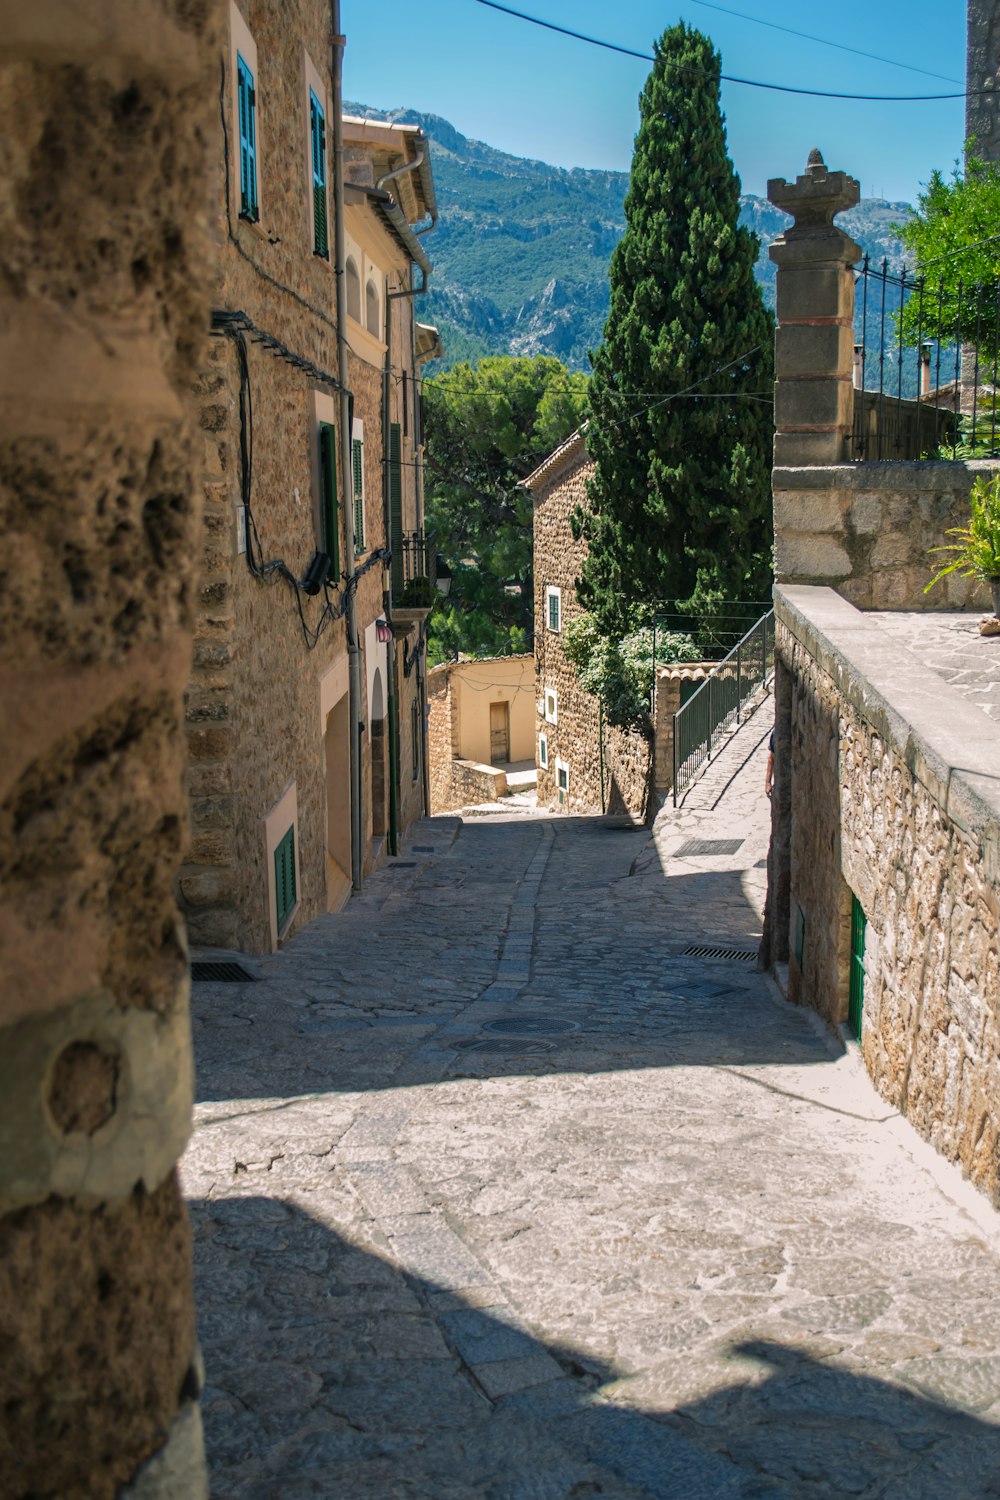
[576, 24, 774, 639]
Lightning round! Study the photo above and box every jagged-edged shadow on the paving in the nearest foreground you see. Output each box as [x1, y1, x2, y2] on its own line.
[190, 1194, 1000, 1500]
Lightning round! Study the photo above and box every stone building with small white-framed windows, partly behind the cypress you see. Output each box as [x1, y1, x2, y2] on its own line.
[525, 429, 654, 819]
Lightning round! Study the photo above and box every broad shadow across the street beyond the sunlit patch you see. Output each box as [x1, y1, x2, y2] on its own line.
[192, 818, 831, 1101]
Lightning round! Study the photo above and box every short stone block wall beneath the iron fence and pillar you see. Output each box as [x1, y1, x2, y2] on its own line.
[772, 461, 996, 609]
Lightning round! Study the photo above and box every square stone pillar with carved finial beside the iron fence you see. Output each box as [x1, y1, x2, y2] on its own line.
[768, 152, 861, 468]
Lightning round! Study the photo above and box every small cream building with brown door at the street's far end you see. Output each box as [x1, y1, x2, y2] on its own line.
[427, 656, 535, 813]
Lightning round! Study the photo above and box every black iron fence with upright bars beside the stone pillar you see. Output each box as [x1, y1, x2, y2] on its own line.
[852, 257, 1000, 461]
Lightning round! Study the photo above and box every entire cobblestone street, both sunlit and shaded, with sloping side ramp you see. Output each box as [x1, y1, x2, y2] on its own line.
[183, 710, 1000, 1500]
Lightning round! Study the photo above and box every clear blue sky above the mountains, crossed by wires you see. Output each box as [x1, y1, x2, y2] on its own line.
[342, 0, 966, 203]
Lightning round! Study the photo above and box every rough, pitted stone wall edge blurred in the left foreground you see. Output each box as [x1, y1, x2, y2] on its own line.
[0, 0, 220, 1500]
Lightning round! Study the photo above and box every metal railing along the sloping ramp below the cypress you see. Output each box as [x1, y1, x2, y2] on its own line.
[673, 609, 774, 807]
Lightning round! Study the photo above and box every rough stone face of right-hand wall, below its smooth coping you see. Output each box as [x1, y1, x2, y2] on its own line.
[778, 624, 1000, 1202]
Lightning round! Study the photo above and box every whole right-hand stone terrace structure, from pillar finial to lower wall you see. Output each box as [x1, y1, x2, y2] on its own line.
[765, 152, 1000, 1202]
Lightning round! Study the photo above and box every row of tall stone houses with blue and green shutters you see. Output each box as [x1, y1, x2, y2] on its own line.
[180, 0, 436, 953]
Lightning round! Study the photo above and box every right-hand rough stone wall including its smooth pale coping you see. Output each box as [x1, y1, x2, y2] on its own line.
[775, 588, 1000, 1202]
